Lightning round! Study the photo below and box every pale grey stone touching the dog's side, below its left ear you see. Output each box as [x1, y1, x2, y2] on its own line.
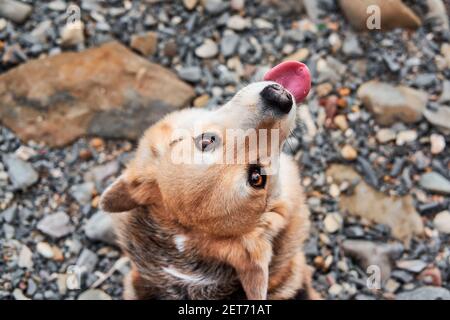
[84, 211, 116, 245]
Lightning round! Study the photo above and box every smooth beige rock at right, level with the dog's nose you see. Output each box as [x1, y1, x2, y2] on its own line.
[357, 80, 428, 125]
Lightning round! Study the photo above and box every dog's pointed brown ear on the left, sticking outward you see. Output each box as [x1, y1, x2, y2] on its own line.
[100, 176, 138, 212]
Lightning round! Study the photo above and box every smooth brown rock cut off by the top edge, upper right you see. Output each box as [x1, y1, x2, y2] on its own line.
[339, 0, 422, 31]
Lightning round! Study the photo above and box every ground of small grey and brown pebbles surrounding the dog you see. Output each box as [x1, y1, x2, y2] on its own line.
[0, 0, 450, 299]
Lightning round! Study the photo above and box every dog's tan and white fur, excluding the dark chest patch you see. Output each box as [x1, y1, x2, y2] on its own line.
[101, 84, 318, 299]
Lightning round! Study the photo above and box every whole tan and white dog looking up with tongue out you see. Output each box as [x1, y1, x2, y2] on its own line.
[100, 63, 320, 300]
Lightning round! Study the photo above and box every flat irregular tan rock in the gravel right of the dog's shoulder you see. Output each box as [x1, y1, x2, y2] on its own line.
[327, 164, 423, 245]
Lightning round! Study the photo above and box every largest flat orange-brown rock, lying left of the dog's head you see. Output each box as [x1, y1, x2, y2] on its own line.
[0, 42, 194, 146]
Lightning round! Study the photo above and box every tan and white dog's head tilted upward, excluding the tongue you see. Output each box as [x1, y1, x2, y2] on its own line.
[101, 62, 310, 236]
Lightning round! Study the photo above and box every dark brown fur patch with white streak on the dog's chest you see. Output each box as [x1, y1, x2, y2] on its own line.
[119, 212, 241, 299]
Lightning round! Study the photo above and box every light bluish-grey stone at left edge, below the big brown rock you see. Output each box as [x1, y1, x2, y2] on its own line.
[3, 154, 39, 190]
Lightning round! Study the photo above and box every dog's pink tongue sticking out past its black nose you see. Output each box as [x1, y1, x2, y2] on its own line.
[264, 61, 311, 103]
